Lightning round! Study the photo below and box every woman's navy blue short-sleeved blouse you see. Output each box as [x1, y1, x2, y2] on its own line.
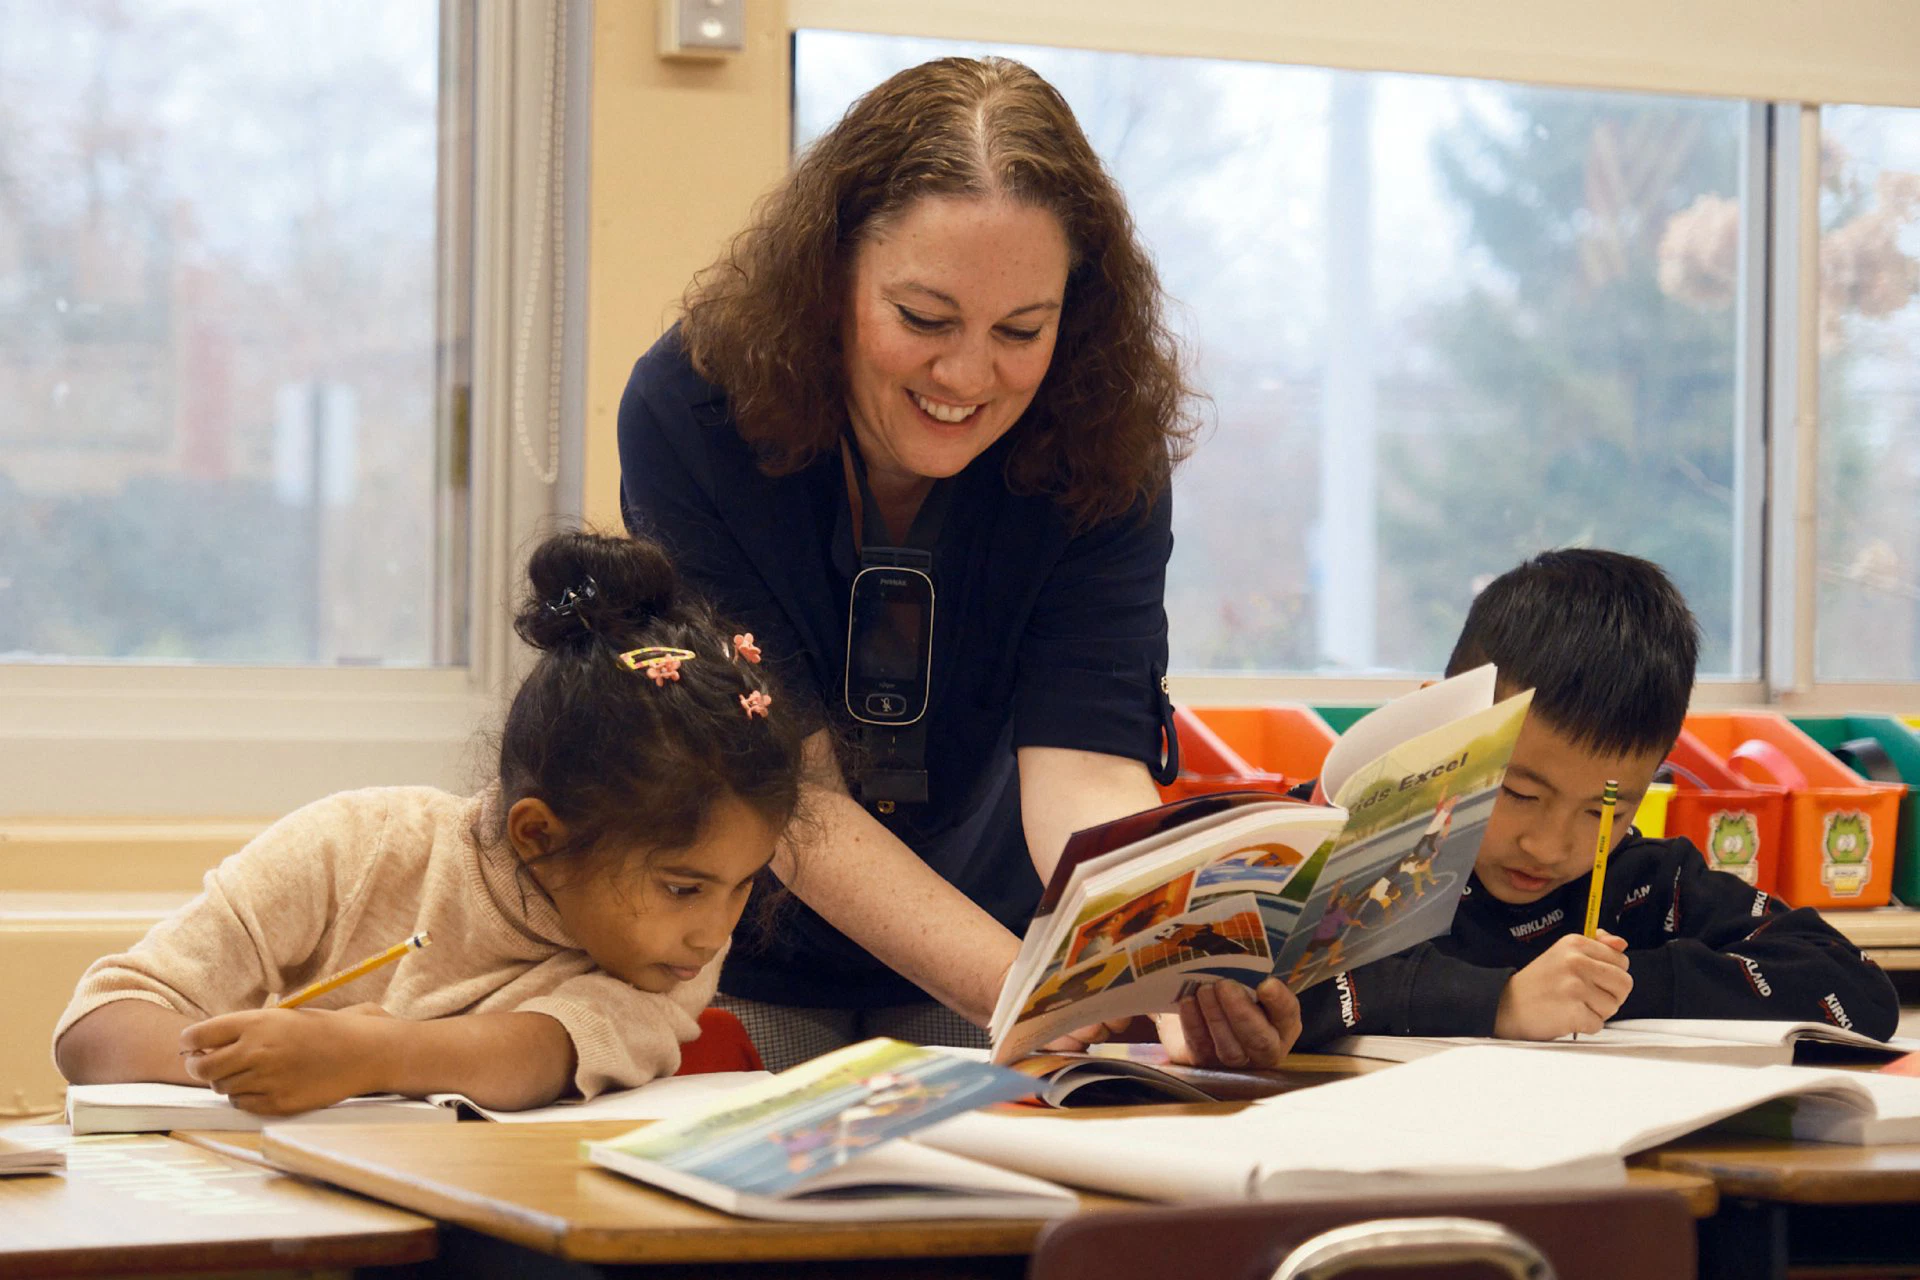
[620, 330, 1173, 1007]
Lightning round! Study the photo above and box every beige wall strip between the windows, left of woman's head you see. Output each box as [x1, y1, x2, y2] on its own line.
[586, 0, 789, 528]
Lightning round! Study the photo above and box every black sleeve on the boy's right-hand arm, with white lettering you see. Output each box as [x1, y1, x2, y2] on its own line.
[1617, 844, 1899, 1040]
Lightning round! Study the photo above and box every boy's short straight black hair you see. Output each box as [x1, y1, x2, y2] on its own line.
[1446, 547, 1699, 754]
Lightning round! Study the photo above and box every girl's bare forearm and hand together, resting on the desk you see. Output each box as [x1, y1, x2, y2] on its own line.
[179, 1006, 574, 1115]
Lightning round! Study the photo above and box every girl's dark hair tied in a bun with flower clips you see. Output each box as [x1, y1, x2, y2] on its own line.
[499, 533, 803, 882]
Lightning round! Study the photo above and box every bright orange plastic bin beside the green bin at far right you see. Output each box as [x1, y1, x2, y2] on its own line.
[1686, 712, 1907, 908]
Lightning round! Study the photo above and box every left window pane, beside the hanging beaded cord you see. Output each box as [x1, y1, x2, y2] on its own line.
[0, 0, 468, 666]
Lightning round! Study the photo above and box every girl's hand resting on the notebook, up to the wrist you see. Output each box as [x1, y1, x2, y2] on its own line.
[180, 1006, 382, 1115]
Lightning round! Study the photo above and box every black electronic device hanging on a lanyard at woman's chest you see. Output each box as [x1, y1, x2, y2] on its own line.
[841, 439, 952, 814]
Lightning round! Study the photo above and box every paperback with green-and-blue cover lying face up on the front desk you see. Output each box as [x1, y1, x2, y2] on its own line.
[584, 1040, 1077, 1221]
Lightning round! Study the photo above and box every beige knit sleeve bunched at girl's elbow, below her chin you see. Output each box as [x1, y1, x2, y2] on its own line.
[515, 944, 732, 1098]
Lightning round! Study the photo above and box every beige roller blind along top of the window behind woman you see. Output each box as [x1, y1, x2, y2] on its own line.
[787, 0, 1920, 104]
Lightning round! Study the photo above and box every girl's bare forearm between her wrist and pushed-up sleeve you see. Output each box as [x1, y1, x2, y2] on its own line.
[353, 1013, 574, 1111]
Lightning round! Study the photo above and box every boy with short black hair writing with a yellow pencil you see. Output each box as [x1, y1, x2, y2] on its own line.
[1300, 551, 1899, 1048]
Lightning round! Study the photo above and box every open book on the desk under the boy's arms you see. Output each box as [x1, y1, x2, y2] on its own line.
[1323, 1017, 1920, 1067]
